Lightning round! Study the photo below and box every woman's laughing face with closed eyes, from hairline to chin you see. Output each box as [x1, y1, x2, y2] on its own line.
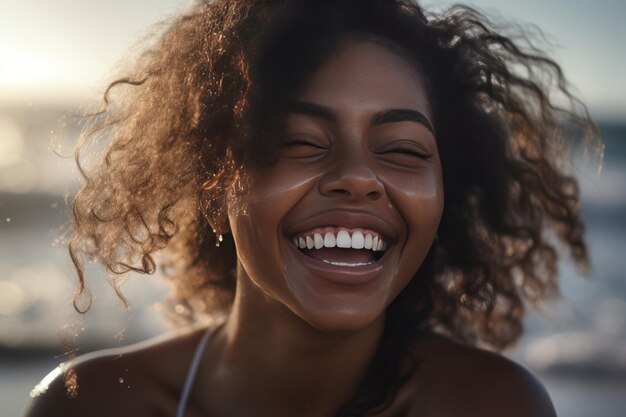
[228, 40, 443, 332]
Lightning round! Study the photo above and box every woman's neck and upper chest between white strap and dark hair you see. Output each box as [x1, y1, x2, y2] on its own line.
[210, 272, 384, 416]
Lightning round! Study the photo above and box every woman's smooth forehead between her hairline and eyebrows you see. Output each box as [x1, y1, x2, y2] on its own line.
[297, 40, 431, 118]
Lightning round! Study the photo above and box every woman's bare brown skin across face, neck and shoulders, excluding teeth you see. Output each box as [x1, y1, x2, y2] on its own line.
[27, 40, 555, 417]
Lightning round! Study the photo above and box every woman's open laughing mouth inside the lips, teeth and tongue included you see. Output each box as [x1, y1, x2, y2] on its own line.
[292, 227, 387, 267]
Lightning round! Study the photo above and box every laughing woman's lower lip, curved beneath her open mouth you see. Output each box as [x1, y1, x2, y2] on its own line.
[284, 237, 391, 285]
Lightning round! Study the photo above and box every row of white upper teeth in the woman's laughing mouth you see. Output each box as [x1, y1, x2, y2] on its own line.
[293, 229, 387, 251]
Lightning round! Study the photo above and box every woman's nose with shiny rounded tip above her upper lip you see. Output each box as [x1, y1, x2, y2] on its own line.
[319, 154, 384, 200]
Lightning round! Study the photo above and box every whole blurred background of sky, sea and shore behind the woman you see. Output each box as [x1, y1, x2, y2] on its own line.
[0, 0, 626, 417]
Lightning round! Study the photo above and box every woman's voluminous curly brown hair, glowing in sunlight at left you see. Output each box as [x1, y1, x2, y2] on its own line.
[69, 0, 598, 415]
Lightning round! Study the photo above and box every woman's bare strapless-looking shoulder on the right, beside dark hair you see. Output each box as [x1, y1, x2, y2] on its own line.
[409, 335, 556, 417]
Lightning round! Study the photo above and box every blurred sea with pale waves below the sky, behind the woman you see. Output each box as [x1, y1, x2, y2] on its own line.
[0, 108, 626, 417]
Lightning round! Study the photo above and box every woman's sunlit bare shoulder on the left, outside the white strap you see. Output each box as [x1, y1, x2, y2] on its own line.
[25, 330, 204, 417]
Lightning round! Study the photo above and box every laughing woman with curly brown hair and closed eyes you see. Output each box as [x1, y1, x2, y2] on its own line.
[27, 0, 595, 417]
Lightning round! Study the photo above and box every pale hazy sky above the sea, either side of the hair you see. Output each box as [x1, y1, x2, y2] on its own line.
[0, 0, 626, 121]
